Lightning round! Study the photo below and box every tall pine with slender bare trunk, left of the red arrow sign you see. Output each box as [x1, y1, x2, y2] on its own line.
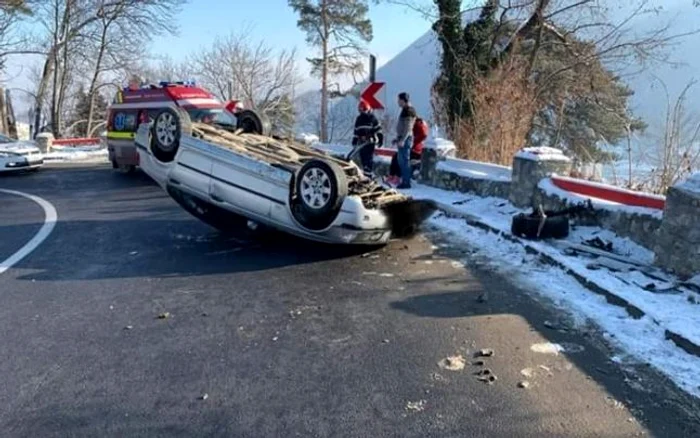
[289, 0, 372, 141]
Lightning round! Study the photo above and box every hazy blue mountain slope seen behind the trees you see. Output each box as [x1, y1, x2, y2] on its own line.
[297, 0, 700, 151]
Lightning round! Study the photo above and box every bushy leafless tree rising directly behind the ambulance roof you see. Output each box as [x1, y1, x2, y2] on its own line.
[190, 31, 301, 136]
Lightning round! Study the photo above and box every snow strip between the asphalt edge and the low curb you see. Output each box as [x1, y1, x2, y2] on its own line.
[430, 215, 700, 397]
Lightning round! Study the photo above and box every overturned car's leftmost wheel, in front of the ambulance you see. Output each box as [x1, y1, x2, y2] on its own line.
[151, 108, 192, 163]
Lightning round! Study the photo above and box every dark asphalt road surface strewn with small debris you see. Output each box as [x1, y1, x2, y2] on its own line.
[0, 165, 700, 437]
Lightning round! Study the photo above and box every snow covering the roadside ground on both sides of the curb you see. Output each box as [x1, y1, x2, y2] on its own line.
[405, 185, 700, 397]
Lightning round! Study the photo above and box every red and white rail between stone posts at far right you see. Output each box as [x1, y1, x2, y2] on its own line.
[551, 176, 666, 210]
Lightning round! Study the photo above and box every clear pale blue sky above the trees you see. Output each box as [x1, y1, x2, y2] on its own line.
[3, 0, 440, 118]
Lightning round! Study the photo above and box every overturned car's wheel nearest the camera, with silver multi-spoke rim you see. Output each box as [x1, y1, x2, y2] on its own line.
[292, 159, 348, 231]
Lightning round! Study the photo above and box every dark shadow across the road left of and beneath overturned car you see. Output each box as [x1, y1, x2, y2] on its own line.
[0, 166, 378, 281]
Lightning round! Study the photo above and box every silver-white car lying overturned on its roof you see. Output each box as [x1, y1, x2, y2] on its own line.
[135, 108, 435, 244]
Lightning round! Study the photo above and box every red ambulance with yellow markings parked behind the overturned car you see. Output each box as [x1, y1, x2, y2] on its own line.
[107, 80, 242, 173]
